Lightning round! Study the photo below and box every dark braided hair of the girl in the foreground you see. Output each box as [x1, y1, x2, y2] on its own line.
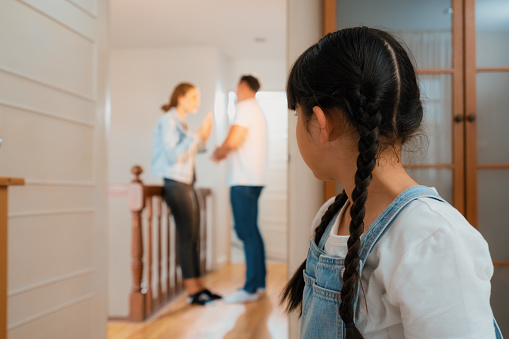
[282, 27, 423, 339]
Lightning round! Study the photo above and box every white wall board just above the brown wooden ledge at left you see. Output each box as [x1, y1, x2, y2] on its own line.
[0, 104, 94, 181]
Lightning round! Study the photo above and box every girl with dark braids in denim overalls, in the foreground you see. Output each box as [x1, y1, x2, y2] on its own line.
[283, 27, 502, 339]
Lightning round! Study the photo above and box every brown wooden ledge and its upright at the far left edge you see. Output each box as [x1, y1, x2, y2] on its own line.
[0, 177, 25, 338]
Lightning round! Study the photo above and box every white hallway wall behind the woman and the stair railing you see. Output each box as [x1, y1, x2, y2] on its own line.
[108, 47, 229, 316]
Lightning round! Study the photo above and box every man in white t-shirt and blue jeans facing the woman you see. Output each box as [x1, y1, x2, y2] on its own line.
[212, 75, 267, 303]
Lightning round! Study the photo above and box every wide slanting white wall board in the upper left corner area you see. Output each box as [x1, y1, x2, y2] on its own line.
[0, 0, 95, 98]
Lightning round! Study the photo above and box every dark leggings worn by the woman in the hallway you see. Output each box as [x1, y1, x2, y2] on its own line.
[164, 179, 201, 279]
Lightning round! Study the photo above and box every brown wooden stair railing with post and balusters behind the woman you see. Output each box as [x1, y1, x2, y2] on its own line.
[127, 166, 212, 321]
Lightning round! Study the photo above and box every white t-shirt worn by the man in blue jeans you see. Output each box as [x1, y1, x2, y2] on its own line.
[228, 98, 267, 186]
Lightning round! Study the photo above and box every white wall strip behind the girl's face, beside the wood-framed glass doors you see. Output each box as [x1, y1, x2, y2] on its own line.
[288, 0, 323, 338]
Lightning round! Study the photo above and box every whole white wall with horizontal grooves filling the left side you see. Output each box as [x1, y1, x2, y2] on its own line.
[0, 0, 108, 339]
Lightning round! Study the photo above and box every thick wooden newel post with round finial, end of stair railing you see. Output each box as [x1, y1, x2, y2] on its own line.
[127, 166, 146, 321]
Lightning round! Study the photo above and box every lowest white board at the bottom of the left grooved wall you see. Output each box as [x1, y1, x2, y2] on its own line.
[7, 297, 95, 339]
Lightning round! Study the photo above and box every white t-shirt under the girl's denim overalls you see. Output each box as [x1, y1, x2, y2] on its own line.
[313, 190, 495, 339]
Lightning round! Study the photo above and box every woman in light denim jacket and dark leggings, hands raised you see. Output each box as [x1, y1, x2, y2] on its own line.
[151, 83, 221, 305]
